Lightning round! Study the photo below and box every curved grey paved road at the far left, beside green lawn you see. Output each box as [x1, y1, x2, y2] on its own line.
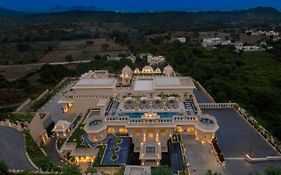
[0, 126, 34, 170]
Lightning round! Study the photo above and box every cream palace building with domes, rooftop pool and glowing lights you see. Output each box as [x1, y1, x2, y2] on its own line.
[60, 65, 219, 166]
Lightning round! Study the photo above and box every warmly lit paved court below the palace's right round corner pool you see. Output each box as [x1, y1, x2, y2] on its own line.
[182, 135, 224, 175]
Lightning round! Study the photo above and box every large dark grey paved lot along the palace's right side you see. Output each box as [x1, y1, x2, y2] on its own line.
[203, 109, 279, 158]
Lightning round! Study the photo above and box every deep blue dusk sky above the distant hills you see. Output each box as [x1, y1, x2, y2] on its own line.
[0, 0, 281, 11]
